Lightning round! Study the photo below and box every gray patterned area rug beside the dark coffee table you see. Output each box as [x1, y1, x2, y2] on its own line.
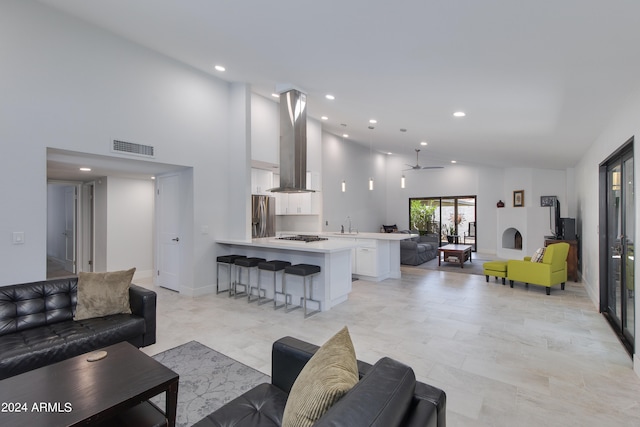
[152, 341, 271, 427]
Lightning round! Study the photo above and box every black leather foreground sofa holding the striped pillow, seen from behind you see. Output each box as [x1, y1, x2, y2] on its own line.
[194, 337, 446, 427]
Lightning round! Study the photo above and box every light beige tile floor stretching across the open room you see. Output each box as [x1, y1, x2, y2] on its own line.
[140, 267, 640, 427]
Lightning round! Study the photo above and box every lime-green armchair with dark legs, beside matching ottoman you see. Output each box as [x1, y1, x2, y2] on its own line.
[507, 242, 569, 295]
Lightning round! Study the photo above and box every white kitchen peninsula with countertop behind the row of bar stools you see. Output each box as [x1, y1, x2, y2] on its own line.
[216, 237, 355, 311]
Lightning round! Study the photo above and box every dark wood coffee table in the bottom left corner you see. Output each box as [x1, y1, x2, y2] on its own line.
[0, 342, 178, 427]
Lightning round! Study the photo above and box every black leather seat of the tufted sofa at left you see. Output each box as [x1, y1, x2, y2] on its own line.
[0, 314, 145, 379]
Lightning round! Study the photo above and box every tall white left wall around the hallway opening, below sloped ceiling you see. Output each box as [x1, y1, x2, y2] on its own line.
[0, 1, 238, 293]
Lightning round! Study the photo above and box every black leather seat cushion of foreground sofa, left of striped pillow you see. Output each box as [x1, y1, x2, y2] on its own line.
[193, 384, 287, 427]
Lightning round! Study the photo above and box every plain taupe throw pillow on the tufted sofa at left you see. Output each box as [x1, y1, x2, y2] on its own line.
[73, 268, 136, 320]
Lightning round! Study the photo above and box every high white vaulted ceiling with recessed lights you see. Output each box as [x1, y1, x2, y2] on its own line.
[40, 0, 640, 169]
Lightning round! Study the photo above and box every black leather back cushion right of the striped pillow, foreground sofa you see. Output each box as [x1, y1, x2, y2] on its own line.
[314, 357, 416, 427]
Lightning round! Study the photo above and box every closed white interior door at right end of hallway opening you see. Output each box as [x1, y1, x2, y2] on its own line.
[156, 174, 181, 291]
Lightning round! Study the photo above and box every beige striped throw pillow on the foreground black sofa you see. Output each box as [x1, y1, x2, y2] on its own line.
[282, 327, 358, 427]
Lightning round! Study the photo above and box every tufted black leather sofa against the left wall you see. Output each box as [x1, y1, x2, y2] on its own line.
[0, 277, 156, 379]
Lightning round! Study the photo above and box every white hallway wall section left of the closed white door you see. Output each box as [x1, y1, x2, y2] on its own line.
[106, 177, 155, 278]
